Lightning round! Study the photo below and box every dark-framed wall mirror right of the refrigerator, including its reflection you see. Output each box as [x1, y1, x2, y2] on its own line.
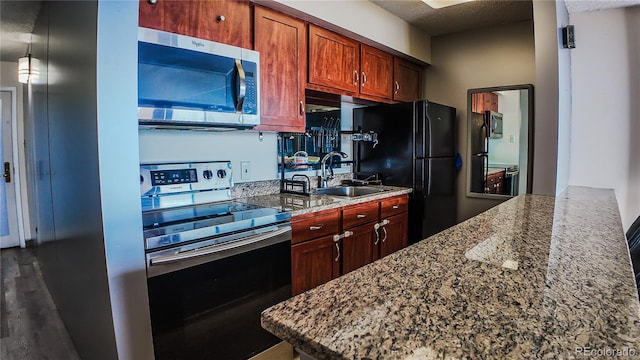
[466, 84, 534, 199]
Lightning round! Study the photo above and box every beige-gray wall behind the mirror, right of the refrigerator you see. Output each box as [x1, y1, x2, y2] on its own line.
[426, 22, 538, 221]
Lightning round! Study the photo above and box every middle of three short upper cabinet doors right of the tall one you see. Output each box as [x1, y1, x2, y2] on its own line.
[360, 44, 393, 99]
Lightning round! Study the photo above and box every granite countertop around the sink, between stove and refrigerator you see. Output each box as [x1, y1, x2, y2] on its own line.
[239, 185, 412, 216]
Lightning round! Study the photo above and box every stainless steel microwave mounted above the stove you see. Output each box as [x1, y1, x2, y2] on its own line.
[138, 27, 260, 129]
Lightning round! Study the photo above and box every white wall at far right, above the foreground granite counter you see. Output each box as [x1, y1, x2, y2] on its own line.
[569, 6, 640, 229]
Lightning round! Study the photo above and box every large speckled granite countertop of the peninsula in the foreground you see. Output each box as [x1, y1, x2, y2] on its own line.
[262, 187, 640, 360]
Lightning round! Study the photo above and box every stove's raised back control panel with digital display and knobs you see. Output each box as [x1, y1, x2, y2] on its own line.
[140, 161, 233, 197]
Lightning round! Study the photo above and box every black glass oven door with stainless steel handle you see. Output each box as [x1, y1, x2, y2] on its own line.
[147, 224, 291, 360]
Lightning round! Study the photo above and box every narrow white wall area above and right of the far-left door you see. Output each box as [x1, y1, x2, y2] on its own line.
[0, 59, 32, 240]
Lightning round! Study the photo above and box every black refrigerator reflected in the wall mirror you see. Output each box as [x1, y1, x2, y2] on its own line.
[469, 113, 489, 193]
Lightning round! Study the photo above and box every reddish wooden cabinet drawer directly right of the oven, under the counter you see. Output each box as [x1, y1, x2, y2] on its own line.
[291, 210, 340, 244]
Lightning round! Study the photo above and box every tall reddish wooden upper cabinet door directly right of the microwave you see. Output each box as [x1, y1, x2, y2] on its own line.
[254, 6, 307, 132]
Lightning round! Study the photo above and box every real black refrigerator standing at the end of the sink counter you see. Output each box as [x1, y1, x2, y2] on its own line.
[353, 100, 456, 243]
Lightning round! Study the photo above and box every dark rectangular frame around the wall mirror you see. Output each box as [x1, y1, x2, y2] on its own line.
[465, 84, 535, 200]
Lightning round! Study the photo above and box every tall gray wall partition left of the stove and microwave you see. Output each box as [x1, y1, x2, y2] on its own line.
[26, 1, 152, 359]
